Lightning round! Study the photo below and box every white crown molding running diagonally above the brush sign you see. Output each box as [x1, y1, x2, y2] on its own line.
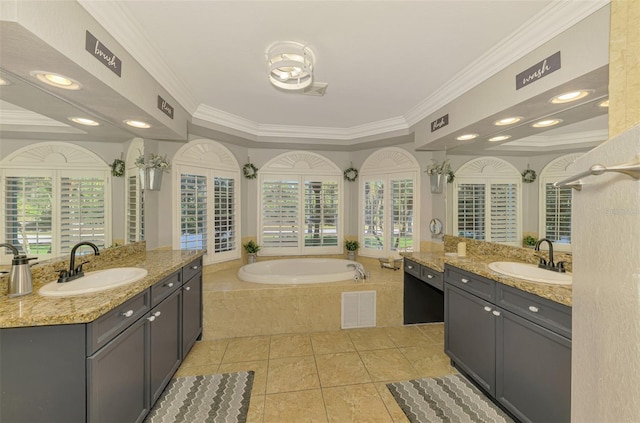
[77, 0, 198, 114]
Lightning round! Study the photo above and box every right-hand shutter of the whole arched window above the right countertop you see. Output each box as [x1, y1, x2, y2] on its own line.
[489, 183, 518, 243]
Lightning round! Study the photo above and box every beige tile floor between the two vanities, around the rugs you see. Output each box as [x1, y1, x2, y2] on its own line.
[176, 324, 456, 423]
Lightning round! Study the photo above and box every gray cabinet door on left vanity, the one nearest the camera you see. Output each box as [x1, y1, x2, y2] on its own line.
[87, 318, 149, 423]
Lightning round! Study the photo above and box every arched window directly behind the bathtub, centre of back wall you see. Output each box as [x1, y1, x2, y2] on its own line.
[258, 152, 342, 255]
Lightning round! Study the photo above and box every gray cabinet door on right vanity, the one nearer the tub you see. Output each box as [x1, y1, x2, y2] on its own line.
[444, 284, 496, 395]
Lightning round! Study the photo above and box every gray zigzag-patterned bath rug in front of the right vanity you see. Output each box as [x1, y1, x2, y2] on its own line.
[387, 375, 513, 423]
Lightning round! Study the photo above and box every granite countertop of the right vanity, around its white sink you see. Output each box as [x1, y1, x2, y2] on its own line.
[403, 252, 572, 307]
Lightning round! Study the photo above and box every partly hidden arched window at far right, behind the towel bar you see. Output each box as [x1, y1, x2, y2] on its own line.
[538, 154, 581, 251]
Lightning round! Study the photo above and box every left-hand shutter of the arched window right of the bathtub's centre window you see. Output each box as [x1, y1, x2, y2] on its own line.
[362, 180, 385, 250]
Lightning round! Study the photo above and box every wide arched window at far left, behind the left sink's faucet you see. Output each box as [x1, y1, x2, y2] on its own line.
[0, 143, 111, 263]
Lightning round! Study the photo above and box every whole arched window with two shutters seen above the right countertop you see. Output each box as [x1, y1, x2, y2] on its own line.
[453, 157, 521, 245]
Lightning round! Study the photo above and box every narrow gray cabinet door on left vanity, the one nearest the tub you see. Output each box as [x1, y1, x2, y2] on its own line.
[182, 272, 202, 358]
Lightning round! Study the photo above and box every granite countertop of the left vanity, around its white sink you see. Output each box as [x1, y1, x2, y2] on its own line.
[0, 250, 204, 328]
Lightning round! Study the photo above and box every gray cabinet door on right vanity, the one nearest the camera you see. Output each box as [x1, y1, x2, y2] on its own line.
[496, 310, 571, 423]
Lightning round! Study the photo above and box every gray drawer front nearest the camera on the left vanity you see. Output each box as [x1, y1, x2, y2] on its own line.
[87, 289, 151, 355]
